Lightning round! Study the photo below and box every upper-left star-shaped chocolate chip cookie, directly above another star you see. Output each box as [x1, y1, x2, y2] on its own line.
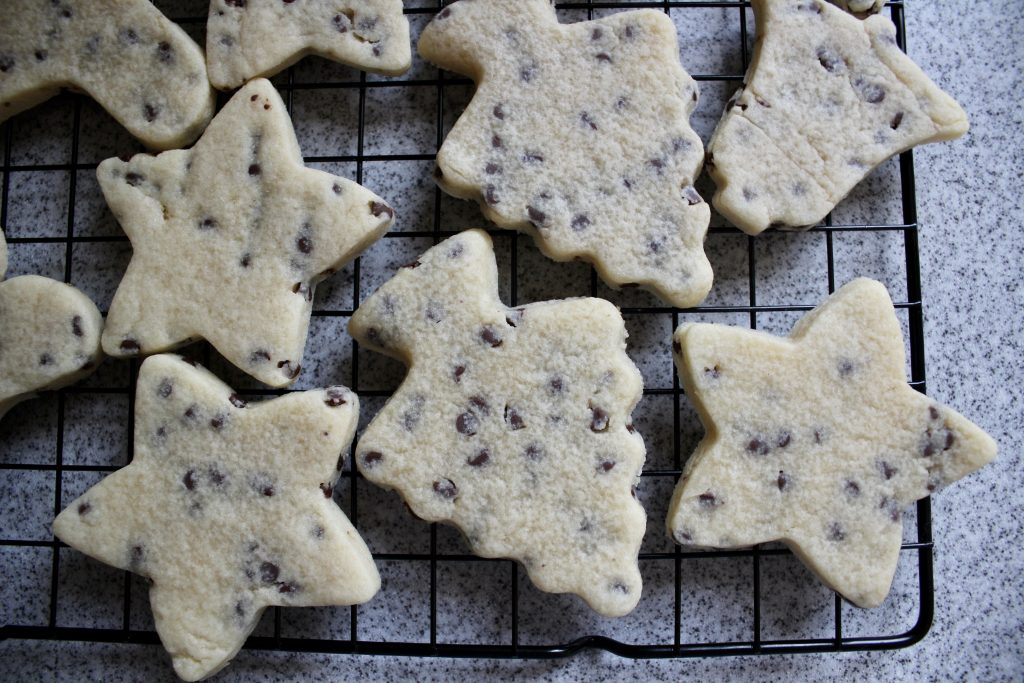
[96, 79, 394, 387]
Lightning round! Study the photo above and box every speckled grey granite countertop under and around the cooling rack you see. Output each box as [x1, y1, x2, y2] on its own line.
[0, 0, 1024, 681]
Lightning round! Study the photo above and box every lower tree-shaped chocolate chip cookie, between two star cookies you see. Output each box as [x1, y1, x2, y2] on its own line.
[349, 230, 645, 615]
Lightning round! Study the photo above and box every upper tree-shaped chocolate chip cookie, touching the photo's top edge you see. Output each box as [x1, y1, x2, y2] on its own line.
[419, 0, 712, 306]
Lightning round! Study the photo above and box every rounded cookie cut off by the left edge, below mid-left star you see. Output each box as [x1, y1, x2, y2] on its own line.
[0, 231, 103, 419]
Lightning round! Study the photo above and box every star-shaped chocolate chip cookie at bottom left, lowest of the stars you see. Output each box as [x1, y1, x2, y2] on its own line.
[53, 355, 380, 681]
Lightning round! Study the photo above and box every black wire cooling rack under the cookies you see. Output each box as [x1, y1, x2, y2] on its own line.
[0, 0, 934, 657]
